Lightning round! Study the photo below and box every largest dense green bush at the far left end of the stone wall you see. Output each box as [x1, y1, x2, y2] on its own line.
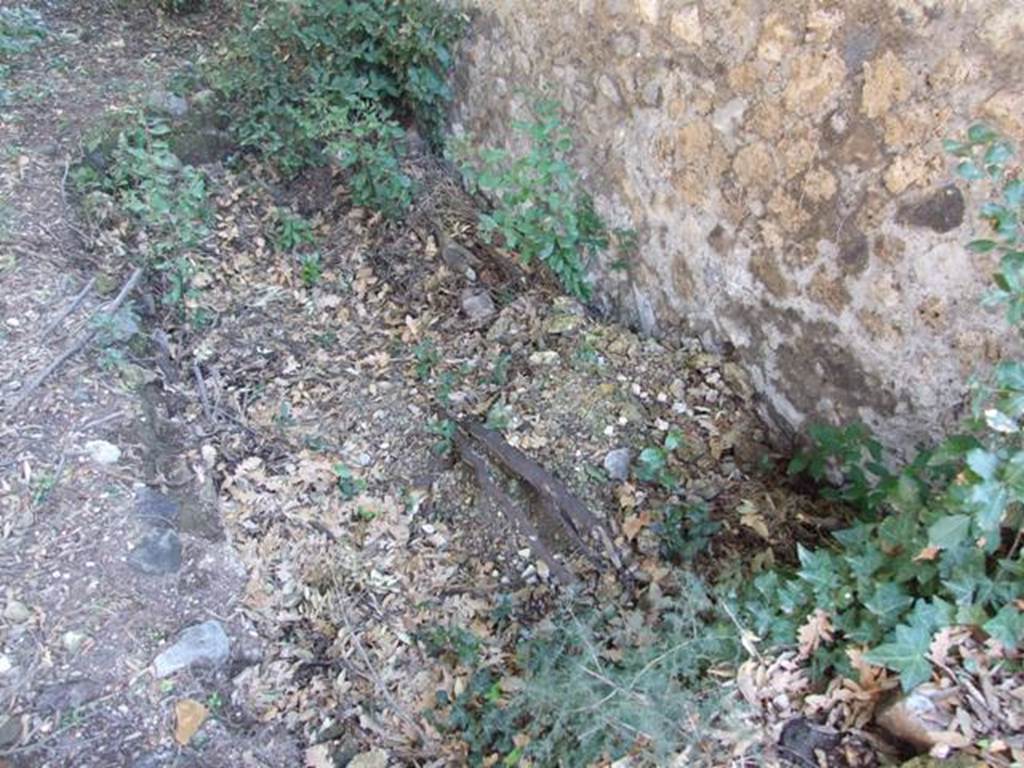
[215, 0, 465, 213]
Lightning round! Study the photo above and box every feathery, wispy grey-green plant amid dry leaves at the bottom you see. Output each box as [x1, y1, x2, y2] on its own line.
[428, 577, 742, 766]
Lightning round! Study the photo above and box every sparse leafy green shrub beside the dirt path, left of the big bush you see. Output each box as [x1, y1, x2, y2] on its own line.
[74, 114, 212, 321]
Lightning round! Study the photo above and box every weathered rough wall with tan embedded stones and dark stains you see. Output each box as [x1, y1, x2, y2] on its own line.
[456, 0, 1024, 454]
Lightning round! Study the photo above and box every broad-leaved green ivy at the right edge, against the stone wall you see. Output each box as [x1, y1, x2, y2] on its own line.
[745, 125, 1024, 689]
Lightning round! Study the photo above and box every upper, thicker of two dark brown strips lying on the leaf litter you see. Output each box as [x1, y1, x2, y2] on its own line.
[456, 421, 623, 569]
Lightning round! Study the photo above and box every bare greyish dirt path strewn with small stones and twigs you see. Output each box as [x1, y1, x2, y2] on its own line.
[0, 2, 299, 768]
